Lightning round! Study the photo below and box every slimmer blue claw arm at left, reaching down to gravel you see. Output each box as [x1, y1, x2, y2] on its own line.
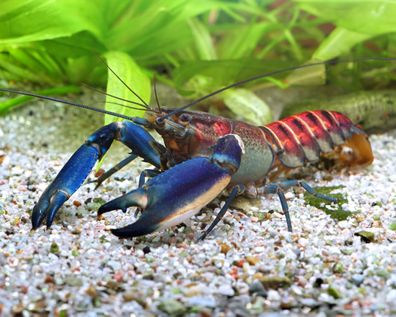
[32, 121, 161, 229]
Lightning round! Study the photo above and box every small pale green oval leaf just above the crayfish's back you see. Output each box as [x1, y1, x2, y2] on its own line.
[223, 89, 273, 125]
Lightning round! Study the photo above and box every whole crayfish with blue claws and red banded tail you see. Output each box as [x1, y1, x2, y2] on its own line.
[1, 58, 380, 239]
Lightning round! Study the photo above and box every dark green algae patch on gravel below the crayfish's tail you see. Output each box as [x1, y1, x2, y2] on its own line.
[304, 186, 353, 221]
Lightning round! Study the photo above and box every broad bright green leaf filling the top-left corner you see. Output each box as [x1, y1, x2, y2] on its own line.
[0, 0, 102, 45]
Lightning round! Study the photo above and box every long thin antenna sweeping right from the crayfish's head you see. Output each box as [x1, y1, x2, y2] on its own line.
[161, 57, 396, 119]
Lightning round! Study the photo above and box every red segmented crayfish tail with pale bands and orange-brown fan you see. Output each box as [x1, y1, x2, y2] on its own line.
[262, 110, 373, 168]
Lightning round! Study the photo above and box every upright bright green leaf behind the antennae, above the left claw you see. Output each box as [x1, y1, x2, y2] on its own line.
[105, 51, 151, 124]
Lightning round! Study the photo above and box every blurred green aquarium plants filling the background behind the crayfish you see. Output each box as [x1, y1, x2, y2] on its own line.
[0, 0, 396, 129]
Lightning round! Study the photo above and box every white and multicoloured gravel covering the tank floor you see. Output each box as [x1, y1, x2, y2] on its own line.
[0, 97, 396, 316]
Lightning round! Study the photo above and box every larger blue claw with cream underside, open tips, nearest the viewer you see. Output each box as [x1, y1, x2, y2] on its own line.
[98, 134, 243, 238]
